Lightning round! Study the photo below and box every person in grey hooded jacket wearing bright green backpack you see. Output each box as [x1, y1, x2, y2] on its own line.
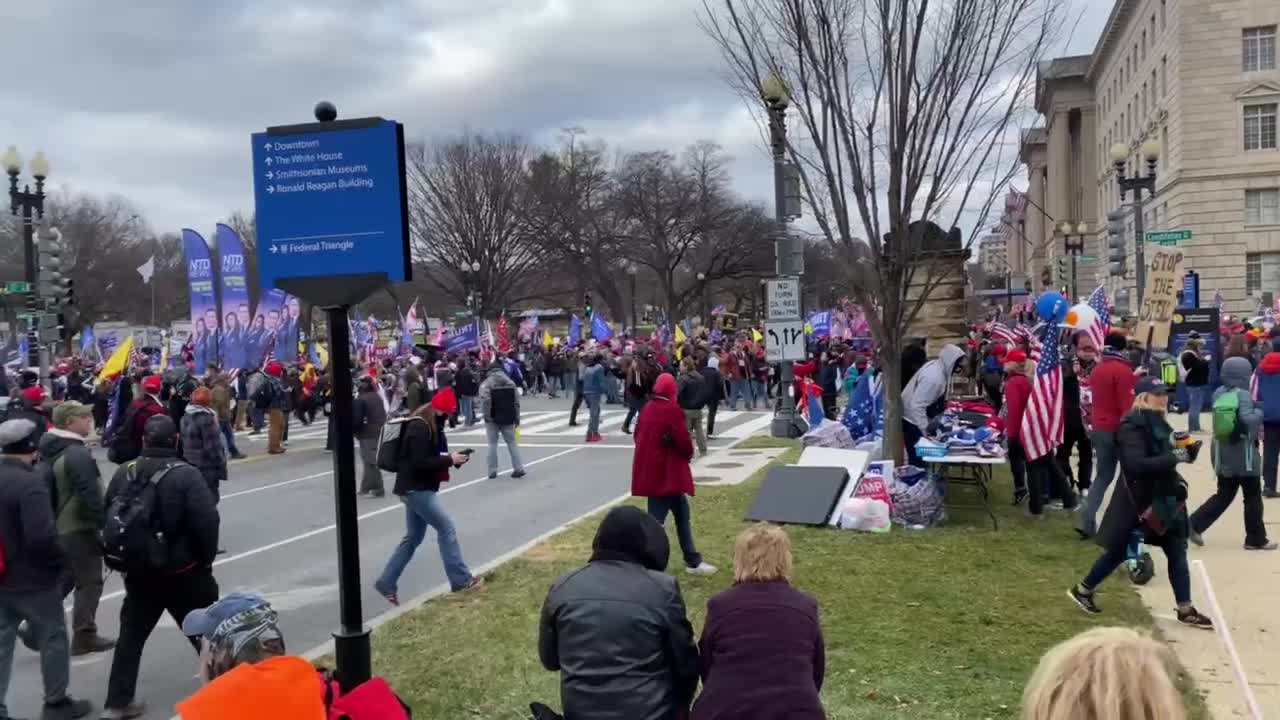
[1190, 357, 1277, 550]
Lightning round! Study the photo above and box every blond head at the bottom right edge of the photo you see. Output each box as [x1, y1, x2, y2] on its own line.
[1021, 628, 1187, 720]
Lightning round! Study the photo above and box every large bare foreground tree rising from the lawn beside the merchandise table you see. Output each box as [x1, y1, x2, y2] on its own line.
[703, 0, 1061, 460]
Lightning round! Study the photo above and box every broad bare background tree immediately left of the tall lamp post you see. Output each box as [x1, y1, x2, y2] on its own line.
[614, 142, 769, 316]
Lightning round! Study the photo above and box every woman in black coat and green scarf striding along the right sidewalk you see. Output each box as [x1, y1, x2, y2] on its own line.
[1066, 378, 1213, 629]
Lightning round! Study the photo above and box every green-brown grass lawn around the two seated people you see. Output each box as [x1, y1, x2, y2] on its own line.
[353, 438, 1204, 720]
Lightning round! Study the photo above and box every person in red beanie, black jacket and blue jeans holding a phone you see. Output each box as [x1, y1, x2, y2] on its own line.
[374, 393, 484, 605]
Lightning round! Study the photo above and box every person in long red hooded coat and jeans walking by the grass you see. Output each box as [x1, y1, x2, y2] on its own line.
[631, 373, 716, 575]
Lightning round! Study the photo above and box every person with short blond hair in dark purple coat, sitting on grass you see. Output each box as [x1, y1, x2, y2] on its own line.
[692, 523, 826, 720]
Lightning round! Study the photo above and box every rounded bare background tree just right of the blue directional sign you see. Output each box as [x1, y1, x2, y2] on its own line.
[407, 135, 543, 316]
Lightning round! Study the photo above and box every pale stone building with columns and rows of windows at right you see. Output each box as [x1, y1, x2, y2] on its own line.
[1005, 0, 1280, 314]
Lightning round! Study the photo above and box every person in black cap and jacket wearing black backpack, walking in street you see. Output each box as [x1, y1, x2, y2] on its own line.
[102, 415, 219, 720]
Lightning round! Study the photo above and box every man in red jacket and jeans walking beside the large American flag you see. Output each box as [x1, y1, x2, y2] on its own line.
[1075, 333, 1134, 538]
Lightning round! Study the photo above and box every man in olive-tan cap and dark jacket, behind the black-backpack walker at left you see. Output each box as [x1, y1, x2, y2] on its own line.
[40, 402, 115, 656]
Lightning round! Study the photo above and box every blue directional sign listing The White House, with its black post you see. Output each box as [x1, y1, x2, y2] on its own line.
[252, 102, 411, 691]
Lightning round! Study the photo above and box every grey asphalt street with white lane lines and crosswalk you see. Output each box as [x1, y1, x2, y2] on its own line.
[8, 398, 768, 719]
